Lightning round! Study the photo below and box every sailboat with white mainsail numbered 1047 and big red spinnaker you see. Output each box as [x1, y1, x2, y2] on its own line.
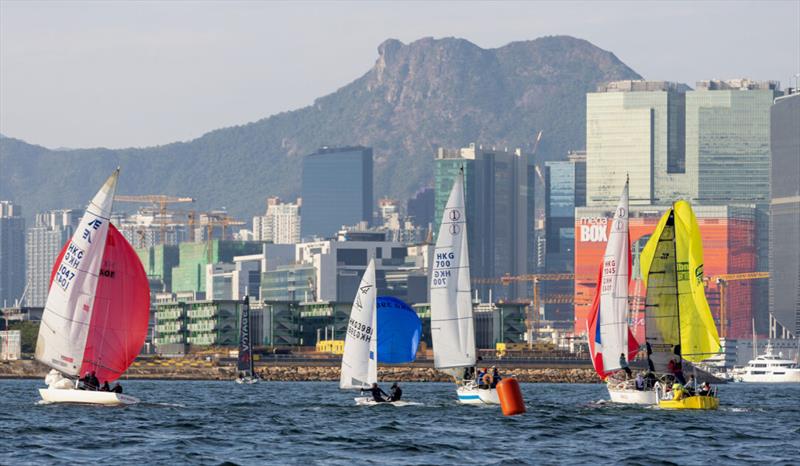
[36, 168, 150, 405]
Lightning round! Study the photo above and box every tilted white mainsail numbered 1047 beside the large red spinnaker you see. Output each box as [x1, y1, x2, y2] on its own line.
[36, 169, 119, 375]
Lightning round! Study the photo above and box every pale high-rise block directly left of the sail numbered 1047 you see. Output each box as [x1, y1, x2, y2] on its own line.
[25, 209, 83, 307]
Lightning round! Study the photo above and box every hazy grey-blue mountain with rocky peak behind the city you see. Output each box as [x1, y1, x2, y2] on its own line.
[0, 36, 640, 219]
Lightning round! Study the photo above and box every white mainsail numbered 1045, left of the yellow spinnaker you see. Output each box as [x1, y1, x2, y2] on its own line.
[596, 182, 630, 372]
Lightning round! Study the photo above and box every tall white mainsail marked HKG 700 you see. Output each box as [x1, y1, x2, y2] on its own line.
[431, 172, 475, 369]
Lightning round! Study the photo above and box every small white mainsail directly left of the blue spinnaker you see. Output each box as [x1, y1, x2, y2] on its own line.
[339, 259, 378, 388]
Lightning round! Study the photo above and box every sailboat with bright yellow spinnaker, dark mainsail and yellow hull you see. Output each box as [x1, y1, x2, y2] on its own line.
[640, 201, 720, 409]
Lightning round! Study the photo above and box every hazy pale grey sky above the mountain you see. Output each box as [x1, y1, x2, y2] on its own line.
[0, 0, 800, 147]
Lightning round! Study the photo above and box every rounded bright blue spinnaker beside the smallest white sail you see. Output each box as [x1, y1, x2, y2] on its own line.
[378, 296, 422, 364]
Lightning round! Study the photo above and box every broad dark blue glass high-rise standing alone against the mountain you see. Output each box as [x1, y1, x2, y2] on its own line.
[300, 147, 373, 238]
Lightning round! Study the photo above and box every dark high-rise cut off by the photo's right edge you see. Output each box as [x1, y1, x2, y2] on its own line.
[769, 92, 800, 336]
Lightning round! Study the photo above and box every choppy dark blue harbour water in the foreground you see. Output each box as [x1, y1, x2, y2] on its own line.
[0, 380, 800, 465]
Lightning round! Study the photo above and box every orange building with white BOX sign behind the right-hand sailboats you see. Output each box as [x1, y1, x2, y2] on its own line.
[574, 206, 756, 341]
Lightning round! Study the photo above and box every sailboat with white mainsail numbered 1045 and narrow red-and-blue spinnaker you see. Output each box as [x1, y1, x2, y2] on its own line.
[588, 180, 656, 404]
